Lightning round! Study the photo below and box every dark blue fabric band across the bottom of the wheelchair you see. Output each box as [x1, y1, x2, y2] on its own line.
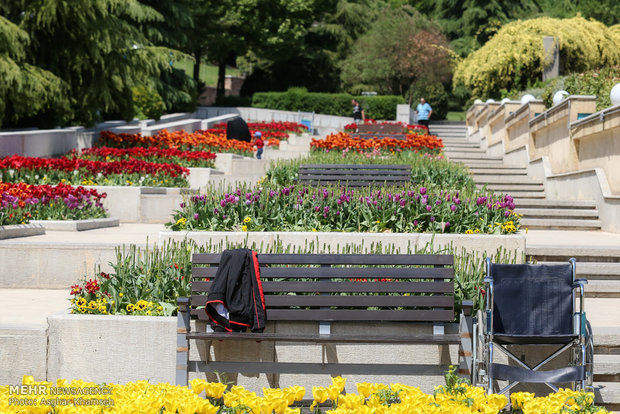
[489, 364, 586, 383]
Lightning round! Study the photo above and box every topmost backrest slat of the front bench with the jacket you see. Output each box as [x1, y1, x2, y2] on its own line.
[192, 253, 454, 266]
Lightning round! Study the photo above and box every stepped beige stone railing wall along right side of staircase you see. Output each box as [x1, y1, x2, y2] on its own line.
[467, 95, 620, 232]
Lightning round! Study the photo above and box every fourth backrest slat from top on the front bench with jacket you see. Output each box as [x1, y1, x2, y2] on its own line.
[191, 295, 454, 309]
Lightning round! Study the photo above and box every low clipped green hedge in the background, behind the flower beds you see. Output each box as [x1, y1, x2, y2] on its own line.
[252, 88, 405, 120]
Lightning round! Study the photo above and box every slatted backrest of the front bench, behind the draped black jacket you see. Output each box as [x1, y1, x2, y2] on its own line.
[190, 253, 454, 322]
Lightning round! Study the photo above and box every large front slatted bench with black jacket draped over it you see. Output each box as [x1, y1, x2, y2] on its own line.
[177, 254, 459, 385]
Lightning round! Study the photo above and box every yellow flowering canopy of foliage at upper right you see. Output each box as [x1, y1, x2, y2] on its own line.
[453, 17, 620, 98]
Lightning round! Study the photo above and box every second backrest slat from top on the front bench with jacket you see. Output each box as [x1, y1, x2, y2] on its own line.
[192, 266, 454, 280]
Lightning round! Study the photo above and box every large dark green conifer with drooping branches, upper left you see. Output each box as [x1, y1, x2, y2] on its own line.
[15, 0, 179, 124]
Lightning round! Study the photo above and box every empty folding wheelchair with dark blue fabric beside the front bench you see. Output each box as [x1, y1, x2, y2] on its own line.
[471, 258, 594, 396]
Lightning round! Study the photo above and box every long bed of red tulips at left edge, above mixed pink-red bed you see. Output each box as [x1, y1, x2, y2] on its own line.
[0, 155, 189, 187]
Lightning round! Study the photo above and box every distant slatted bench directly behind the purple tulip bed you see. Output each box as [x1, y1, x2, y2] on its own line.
[299, 164, 411, 187]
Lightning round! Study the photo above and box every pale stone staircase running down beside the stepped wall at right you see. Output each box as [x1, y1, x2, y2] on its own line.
[431, 124, 620, 410]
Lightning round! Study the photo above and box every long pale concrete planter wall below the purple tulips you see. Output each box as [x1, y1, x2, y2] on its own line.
[159, 230, 525, 258]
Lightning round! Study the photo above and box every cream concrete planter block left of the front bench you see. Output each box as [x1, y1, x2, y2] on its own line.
[47, 313, 177, 384]
